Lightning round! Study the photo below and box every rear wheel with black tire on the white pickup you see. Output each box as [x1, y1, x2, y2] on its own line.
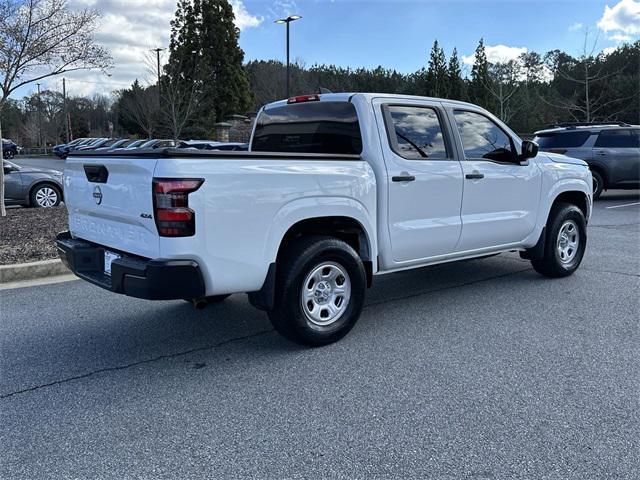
[268, 236, 367, 347]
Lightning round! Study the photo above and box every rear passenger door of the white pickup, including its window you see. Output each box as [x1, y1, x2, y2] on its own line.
[374, 99, 463, 266]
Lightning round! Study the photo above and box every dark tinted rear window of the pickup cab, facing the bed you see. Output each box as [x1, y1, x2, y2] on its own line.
[251, 101, 362, 155]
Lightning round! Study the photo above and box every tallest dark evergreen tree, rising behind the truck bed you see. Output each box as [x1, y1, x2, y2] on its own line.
[165, 0, 252, 135]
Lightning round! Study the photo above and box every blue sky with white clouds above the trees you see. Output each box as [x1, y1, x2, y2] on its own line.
[13, 0, 640, 97]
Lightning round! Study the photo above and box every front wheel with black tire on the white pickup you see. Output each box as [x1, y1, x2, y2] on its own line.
[531, 203, 587, 278]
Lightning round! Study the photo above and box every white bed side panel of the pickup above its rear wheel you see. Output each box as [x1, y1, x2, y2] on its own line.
[155, 158, 377, 295]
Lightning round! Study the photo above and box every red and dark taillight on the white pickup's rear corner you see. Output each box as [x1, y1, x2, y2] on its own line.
[153, 178, 204, 237]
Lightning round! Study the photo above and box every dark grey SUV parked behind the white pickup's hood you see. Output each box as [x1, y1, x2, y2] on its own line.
[534, 123, 640, 198]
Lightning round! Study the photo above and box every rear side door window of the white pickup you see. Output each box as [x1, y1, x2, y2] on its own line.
[387, 105, 448, 160]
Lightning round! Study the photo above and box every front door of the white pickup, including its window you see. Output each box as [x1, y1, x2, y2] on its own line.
[452, 109, 542, 252]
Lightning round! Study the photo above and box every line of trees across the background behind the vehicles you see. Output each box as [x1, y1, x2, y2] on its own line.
[1, 0, 640, 146]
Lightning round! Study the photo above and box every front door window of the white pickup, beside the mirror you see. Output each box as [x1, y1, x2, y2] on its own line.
[454, 110, 517, 162]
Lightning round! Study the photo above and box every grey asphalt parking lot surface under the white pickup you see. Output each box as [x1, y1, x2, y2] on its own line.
[0, 191, 640, 479]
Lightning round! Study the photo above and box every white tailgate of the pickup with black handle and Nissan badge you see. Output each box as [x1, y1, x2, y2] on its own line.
[64, 156, 160, 258]
